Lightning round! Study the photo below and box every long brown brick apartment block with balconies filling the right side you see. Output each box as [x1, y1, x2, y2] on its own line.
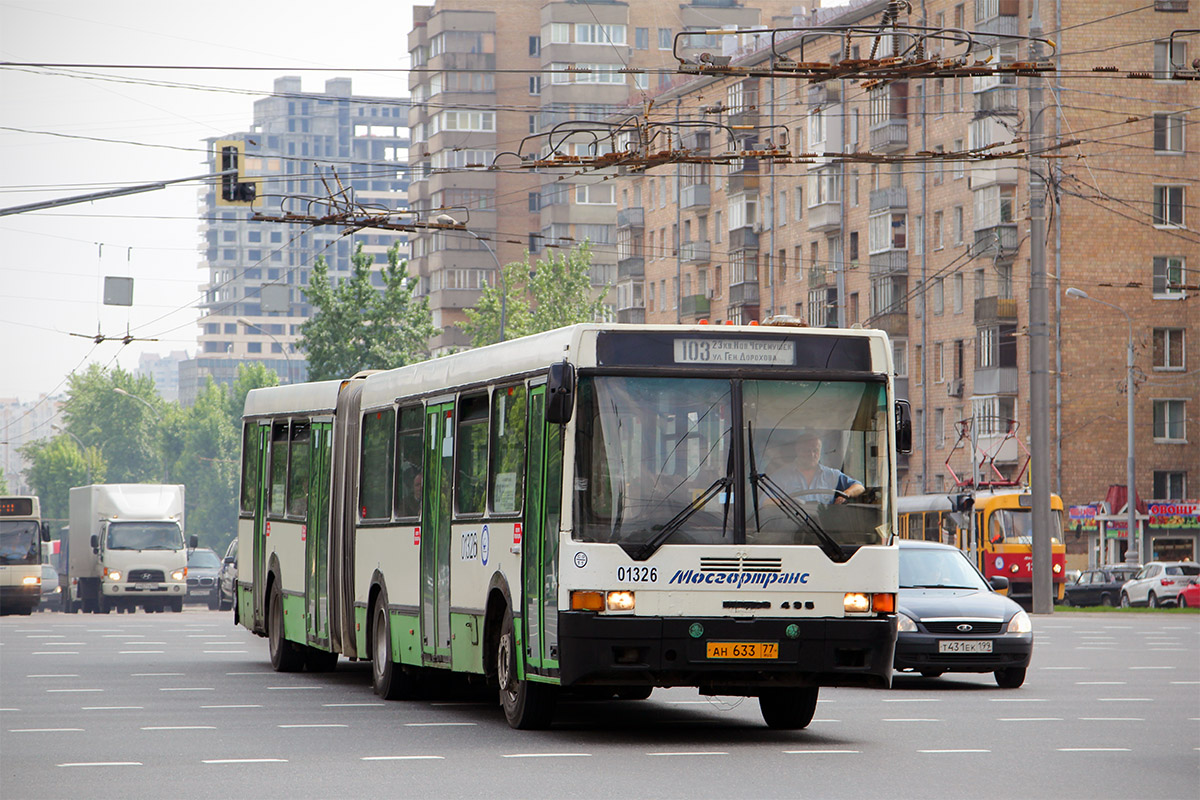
[616, 0, 1200, 563]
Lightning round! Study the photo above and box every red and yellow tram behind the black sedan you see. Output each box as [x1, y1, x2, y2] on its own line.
[896, 487, 1067, 601]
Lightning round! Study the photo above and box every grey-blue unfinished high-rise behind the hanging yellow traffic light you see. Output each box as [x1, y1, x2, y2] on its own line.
[179, 77, 408, 405]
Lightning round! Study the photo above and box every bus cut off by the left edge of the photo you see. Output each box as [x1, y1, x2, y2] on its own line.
[0, 497, 50, 614]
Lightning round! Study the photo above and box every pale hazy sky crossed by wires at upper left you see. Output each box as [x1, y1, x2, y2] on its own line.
[0, 0, 414, 401]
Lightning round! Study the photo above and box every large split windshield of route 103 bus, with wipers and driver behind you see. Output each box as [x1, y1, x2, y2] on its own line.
[574, 375, 888, 548]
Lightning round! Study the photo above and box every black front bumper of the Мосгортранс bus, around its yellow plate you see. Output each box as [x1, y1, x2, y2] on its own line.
[558, 612, 896, 696]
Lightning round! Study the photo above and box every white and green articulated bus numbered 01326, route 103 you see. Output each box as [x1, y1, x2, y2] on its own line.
[235, 324, 911, 728]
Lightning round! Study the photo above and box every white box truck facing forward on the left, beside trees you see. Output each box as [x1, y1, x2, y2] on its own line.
[62, 483, 196, 614]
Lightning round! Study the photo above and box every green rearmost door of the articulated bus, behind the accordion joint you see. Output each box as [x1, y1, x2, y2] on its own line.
[305, 421, 334, 645]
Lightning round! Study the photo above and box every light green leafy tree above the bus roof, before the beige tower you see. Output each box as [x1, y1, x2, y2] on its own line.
[462, 242, 608, 347]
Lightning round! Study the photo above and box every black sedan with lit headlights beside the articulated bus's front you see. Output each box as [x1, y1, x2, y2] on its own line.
[895, 540, 1033, 688]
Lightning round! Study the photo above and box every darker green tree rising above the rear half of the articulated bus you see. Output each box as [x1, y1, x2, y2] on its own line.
[300, 242, 437, 380]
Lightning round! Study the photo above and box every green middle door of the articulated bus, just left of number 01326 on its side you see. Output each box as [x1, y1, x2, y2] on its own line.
[421, 402, 454, 663]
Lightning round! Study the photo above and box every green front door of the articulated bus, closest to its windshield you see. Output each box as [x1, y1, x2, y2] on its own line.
[521, 385, 563, 669]
